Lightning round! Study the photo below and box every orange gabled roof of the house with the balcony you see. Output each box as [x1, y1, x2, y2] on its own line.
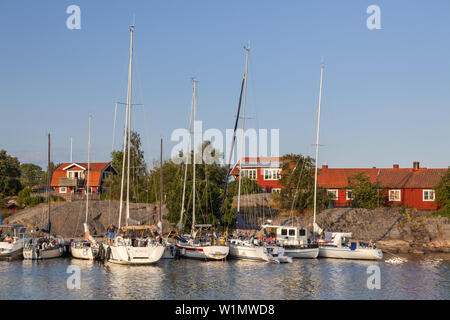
[51, 162, 117, 187]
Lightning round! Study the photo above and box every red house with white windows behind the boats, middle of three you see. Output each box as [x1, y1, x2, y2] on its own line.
[231, 157, 281, 193]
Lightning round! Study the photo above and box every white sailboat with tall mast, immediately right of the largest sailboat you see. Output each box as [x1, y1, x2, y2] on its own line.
[176, 79, 229, 260]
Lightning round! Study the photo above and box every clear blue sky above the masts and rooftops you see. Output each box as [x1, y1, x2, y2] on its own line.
[0, 0, 450, 167]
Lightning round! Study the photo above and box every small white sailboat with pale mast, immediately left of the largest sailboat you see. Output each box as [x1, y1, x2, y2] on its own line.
[70, 117, 99, 260]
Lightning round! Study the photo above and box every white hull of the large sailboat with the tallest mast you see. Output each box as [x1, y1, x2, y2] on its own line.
[105, 245, 165, 265]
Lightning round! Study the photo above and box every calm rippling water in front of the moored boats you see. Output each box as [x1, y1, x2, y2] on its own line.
[0, 256, 450, 299]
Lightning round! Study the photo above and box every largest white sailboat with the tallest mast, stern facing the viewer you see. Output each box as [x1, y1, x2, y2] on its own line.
[102, 25, 165, 265]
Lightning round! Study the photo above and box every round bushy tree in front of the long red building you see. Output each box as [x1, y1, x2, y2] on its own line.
[348, 173, 385, 209]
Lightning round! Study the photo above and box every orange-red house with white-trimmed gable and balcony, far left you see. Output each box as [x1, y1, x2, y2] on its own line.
[51, 162, 117, 196]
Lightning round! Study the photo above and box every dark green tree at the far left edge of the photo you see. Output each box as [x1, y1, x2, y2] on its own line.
[0, 150, 22, 198]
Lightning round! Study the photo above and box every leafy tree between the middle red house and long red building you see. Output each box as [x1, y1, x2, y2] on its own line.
[276, 154, 329, 212]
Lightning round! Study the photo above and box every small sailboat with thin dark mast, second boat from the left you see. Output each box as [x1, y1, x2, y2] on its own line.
[23, 134, 64, 260]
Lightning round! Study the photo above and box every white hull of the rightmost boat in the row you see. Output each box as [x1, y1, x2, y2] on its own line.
[319, 246, 383, 260]
